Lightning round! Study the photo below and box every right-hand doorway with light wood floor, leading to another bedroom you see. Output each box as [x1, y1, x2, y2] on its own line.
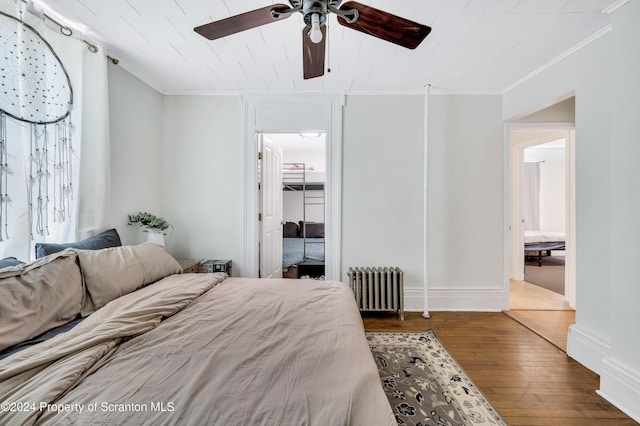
[507, 124, 575, 351]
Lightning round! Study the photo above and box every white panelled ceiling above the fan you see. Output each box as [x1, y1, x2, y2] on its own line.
[28, 0, 620, 94]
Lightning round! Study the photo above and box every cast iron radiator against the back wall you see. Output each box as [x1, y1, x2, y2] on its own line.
[348, 267, 404, 320]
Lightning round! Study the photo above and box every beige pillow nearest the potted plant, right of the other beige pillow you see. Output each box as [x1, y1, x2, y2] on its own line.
[75, 243, 182, 316]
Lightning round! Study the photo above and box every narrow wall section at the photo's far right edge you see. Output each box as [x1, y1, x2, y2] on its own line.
[611, 1, 640, 372]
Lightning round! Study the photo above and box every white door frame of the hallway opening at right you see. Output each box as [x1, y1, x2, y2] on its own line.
[505, 122, 576, 309]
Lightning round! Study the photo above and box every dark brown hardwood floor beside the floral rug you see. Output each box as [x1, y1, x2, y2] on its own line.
[363, 312, 638, 426]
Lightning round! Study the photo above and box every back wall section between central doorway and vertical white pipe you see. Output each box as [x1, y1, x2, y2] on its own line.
[342, 96, 424, 310]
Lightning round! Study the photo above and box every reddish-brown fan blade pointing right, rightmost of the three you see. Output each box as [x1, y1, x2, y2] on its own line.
[337, 1, 431, 49]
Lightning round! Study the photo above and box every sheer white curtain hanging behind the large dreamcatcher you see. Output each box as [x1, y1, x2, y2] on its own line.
[0, 0, 110, 261]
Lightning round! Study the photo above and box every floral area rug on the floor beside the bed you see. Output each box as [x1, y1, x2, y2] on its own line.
[366, 330, 506, 426]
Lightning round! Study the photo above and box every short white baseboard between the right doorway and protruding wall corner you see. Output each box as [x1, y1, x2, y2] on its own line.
[567, 324, 611, 374]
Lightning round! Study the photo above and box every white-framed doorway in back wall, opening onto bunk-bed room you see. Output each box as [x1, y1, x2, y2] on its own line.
[243, 94, 344, 281]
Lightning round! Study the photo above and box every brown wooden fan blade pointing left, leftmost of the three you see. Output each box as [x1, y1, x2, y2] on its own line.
[193, 4, 291, 40]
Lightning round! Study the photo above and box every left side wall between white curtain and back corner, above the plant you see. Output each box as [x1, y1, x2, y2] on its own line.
[107, 64, 165, 244]
